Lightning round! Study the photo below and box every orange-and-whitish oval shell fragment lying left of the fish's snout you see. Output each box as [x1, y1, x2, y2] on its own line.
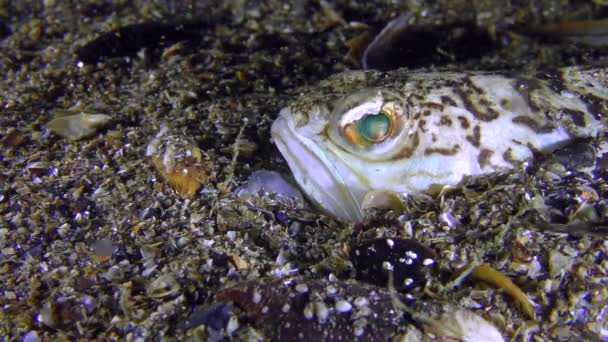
[146, 126, 209, 198]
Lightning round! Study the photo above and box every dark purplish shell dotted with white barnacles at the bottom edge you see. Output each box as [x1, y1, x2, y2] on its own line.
[215, 279, 406, 341]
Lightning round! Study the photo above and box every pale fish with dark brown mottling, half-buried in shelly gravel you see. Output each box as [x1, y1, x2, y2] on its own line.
[272, 67, 608, 222]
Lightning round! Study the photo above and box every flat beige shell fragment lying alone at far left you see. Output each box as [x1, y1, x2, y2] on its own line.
[47, 113, 111, 141]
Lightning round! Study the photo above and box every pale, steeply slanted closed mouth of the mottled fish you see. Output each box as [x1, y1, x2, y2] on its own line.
[271, 108, 363, 222]
